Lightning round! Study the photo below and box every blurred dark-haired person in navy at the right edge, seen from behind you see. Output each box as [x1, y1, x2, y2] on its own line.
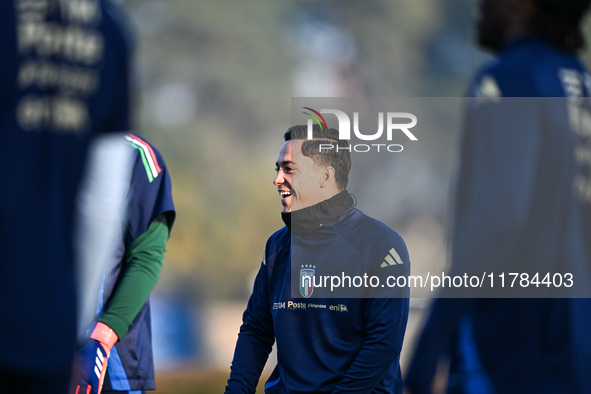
[405, 0, 591, 394]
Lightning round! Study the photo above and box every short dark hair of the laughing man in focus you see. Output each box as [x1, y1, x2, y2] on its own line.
[283, 124, 351, 190]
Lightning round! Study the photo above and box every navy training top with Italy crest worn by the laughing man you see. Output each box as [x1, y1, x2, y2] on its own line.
[226, 192, 410, 393]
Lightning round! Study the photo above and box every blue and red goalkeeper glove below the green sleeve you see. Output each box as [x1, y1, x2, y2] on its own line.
[70, 322, 119, 394]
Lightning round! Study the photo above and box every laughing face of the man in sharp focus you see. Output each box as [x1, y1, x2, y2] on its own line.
[273, 140, 324, 212]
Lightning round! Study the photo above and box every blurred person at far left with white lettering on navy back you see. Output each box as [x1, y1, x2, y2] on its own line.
[0, 0, 130, 393]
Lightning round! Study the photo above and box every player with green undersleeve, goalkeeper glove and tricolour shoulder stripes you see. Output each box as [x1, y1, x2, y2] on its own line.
[70, 134, 175, 394]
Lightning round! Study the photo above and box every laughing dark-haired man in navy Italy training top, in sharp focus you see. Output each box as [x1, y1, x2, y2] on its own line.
[226, 125, 410, 393]
